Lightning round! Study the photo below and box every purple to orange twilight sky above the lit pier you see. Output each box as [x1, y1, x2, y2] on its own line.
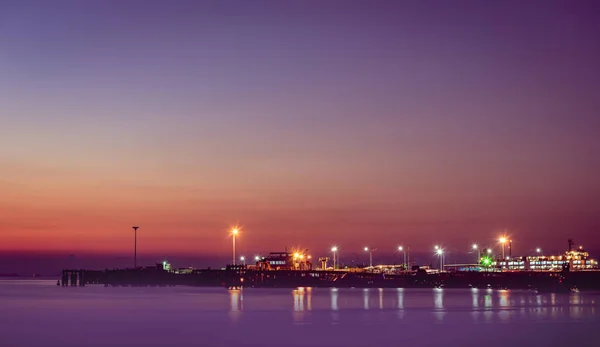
[0, 0, 600, 270]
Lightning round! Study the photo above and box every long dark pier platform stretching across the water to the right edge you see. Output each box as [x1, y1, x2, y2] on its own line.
[57, 265, 600, 291]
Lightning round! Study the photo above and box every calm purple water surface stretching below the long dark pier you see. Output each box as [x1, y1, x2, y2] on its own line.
[0, 280, 600, 347]
